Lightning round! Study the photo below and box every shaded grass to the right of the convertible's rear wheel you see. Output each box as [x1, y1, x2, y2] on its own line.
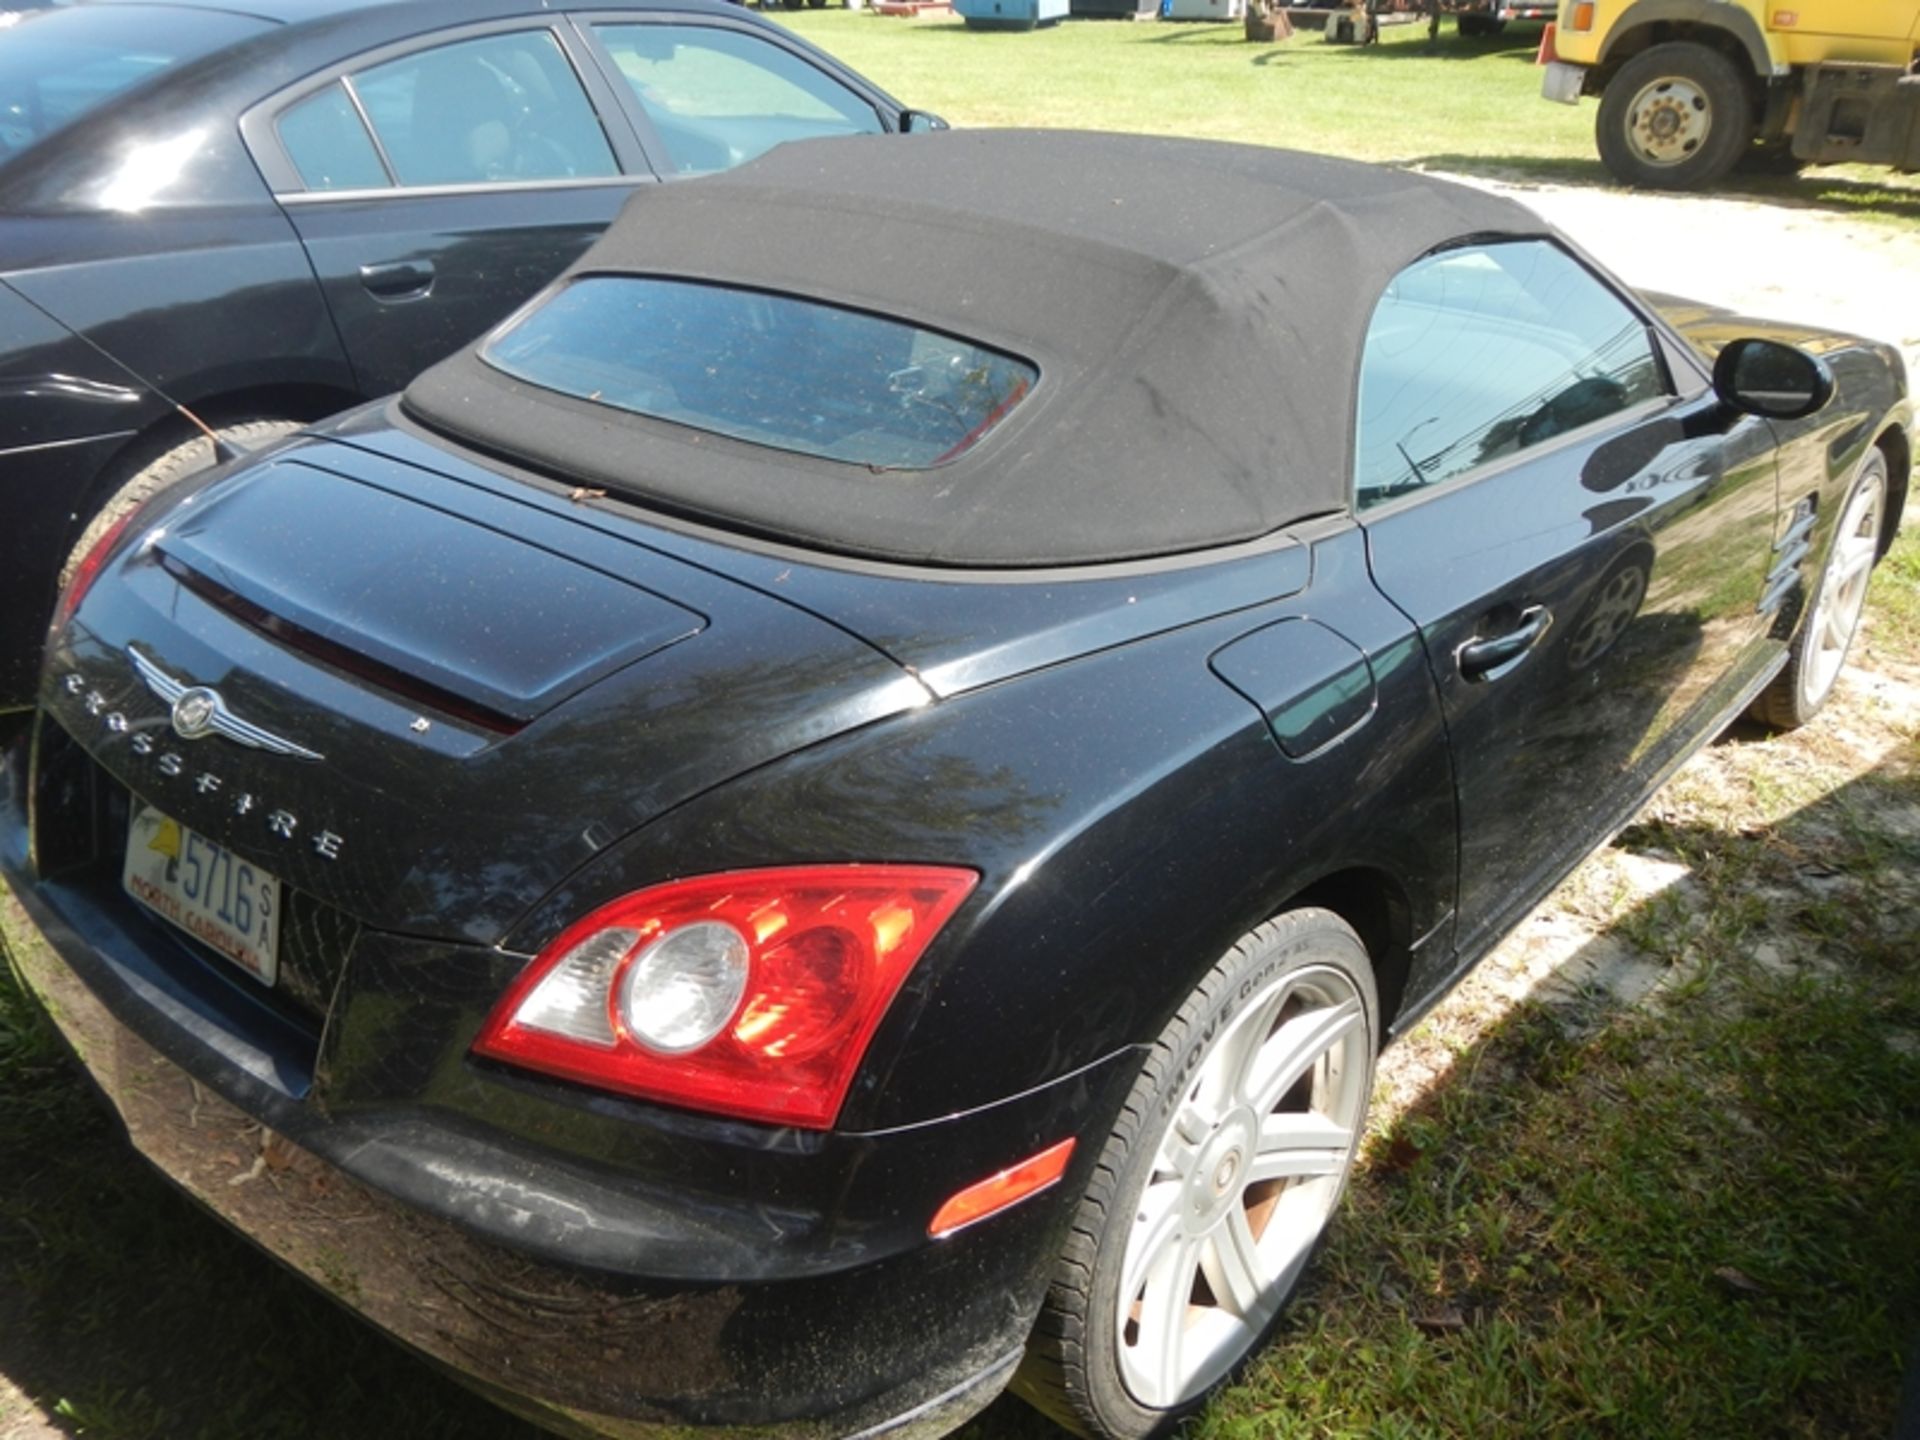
[1198, 732, 1920, 1440]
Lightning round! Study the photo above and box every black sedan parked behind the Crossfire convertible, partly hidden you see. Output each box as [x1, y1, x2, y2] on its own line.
[0, 0, 937, 710]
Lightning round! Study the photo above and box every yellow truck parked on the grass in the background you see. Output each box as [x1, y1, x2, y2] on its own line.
[1540, 0, 1920, 190]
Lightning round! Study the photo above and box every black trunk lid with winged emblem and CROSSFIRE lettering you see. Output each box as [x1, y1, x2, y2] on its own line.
[42, 442, 927, 943]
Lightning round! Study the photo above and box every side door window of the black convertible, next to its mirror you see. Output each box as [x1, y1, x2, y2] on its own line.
[1354, 240, 1663, 509]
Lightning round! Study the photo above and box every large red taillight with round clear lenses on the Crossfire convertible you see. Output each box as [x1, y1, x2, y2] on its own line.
[474, 866, 979, 1129]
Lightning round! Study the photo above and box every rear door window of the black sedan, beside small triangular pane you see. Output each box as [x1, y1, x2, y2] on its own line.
[347, 31, 620, 184]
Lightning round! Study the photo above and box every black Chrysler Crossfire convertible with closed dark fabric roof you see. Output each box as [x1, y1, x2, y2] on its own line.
[0, 132, 1912, 1436]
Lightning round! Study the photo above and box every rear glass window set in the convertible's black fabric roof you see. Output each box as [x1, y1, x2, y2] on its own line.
[480, 275, 1039, 470]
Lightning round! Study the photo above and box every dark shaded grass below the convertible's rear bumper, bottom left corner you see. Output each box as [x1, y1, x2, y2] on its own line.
[0, 1006, 541, 1440]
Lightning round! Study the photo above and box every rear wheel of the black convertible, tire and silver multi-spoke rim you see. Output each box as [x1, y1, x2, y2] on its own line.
[1014, 910, 1379, 1440]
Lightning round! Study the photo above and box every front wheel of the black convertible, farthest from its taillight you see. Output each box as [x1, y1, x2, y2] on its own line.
[1751, 445, 1887, 730]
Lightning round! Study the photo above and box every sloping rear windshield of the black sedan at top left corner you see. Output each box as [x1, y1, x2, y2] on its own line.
[0, 6, 267, 163]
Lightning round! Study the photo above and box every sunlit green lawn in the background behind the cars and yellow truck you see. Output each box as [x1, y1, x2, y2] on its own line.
[774, 10, 1920, 225]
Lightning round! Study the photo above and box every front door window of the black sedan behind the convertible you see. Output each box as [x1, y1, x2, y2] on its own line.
[593, 25, 883, 175]
